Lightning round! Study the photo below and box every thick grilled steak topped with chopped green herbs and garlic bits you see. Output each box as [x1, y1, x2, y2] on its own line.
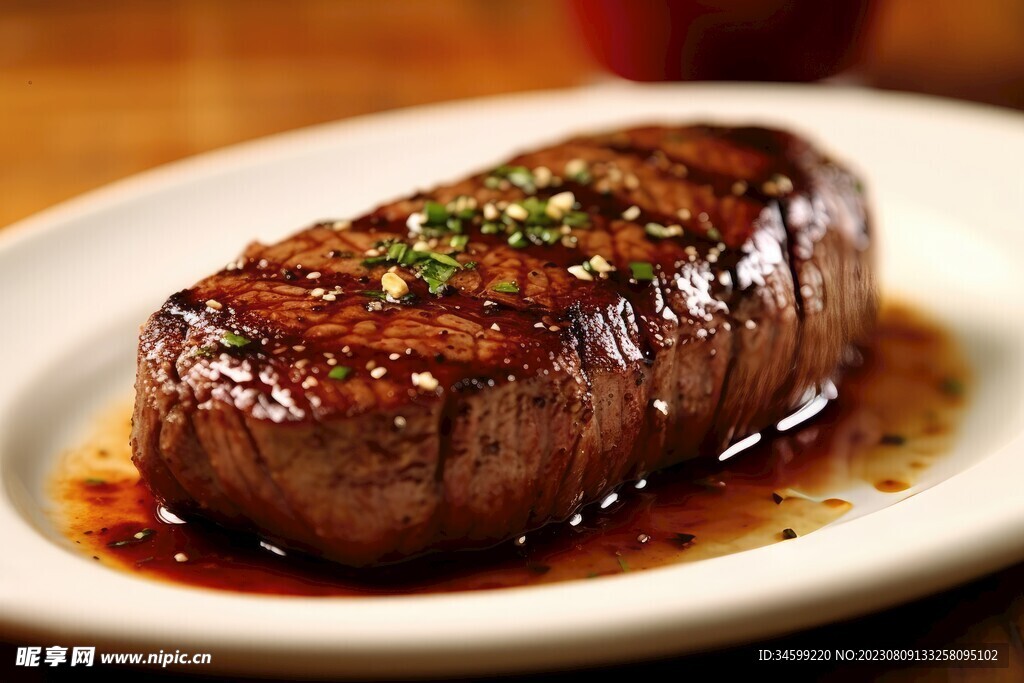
[132, 126, 876, 565]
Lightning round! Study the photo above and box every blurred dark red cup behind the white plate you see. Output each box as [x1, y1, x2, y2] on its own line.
[569, 0, 871, 81]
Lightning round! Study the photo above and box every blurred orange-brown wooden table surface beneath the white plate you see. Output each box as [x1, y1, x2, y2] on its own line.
[0, 0, 1024, 681]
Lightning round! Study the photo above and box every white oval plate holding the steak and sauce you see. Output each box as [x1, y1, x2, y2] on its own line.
[0, 84, 1024, 675]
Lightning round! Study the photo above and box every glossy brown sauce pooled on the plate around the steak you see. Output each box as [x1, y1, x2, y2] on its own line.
[53, 305, 970, 596]
